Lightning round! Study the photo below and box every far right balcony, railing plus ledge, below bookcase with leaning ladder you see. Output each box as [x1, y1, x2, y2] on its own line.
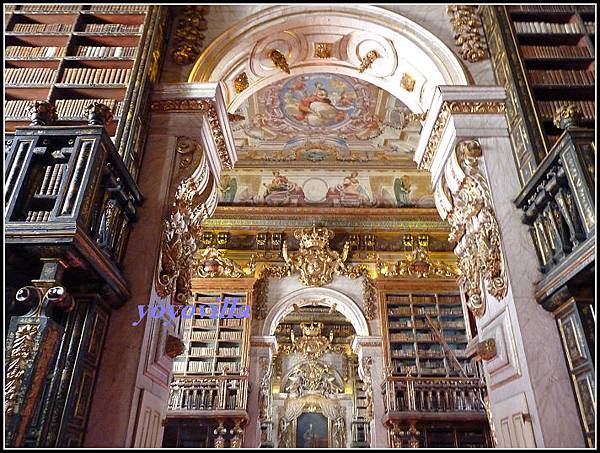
[382, 377, 486, 424]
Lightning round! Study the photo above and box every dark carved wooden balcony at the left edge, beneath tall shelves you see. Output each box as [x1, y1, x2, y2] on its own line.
[4, 125, 142, 304]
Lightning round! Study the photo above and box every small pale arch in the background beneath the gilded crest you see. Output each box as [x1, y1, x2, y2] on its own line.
[261, 288, 369, 336]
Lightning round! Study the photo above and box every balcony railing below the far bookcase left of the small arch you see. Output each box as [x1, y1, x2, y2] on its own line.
[168, 376, 248, 411]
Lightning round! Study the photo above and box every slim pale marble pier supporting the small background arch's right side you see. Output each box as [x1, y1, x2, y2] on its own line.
[352, 336, 390, 448]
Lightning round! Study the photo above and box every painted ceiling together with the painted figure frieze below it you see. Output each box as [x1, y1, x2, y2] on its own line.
[219, 74, 434, 208]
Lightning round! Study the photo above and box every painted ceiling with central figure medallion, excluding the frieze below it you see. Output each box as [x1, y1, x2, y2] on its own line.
[233, 74, 421, 168]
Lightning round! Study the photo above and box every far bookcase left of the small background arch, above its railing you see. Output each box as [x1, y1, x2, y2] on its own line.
[173, 279, 253, 378]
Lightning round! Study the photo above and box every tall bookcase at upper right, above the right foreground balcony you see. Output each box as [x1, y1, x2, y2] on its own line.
[498, 5, 596, 150]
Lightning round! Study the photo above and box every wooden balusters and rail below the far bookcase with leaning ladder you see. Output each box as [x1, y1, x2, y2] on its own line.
[382, 377, 485, 413]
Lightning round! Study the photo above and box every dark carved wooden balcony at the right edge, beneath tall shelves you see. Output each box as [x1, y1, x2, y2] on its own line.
[516, 128, 596, 306]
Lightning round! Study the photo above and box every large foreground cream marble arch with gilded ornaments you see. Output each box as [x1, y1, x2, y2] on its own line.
[188, 4, 469, 113]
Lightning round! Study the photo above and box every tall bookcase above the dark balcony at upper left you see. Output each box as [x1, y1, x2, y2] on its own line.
[4, 4, 167, 179]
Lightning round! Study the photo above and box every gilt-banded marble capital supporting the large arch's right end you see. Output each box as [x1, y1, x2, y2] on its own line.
[414, 86, 508, 184]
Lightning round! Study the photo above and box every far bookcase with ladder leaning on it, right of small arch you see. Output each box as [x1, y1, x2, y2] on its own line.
[377, 280, 477, 377]
